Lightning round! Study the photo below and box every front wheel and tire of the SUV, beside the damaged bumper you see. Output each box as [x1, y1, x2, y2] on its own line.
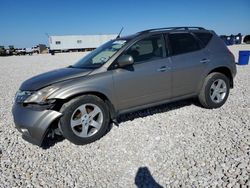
[59, 95, 110, 145]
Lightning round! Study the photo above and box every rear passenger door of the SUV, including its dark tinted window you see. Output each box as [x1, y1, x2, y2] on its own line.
[168, 32, 209, 97]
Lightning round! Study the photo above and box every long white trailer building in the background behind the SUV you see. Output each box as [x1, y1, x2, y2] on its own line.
[49, 34, 117, 51]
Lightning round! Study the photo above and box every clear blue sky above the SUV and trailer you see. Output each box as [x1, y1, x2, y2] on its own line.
[0, 0, 250, 47]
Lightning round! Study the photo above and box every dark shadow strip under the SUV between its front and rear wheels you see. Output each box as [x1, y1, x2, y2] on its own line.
[113, 98, 201, 126]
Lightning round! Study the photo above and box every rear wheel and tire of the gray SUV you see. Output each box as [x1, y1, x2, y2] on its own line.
[198, 72, 230, 109]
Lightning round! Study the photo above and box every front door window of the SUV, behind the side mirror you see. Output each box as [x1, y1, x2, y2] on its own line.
[125, 35, 164, 63]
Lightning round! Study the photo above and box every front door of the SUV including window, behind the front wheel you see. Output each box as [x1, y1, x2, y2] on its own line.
[113, 34, 171, 110]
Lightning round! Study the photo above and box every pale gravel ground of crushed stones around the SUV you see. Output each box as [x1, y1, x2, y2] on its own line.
[0, 49, 250, 188]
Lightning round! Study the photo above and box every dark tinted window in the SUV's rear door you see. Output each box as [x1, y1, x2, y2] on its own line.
[169, 33, 200, 55]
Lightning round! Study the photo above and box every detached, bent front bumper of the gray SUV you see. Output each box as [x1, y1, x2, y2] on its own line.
[12, 103, 62, 146]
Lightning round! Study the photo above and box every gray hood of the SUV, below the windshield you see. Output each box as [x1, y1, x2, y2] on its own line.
[20, 68, 93, 91]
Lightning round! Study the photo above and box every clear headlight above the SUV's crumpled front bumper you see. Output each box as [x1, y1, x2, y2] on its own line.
[24, 87, 59, 103]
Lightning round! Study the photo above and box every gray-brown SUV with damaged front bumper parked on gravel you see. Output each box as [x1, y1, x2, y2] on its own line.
[12, 27, 236, 145]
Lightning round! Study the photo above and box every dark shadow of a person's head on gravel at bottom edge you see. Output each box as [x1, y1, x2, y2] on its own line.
[135, 167, 163, 188]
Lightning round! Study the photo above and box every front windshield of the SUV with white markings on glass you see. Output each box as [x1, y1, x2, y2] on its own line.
[70, 39, 127, 68]
